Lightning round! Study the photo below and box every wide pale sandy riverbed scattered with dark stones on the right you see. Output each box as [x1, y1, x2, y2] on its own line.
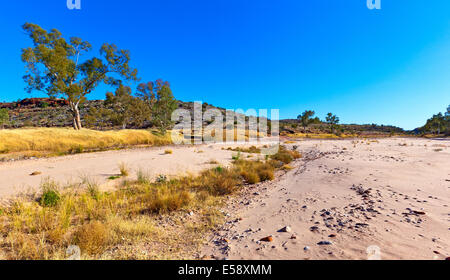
[203, 139, 450, 260]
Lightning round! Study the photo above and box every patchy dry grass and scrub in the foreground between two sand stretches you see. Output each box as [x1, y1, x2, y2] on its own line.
[0, 147, 302, 259]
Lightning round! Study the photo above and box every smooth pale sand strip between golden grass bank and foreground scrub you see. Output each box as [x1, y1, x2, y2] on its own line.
[0, 144, 264, 198]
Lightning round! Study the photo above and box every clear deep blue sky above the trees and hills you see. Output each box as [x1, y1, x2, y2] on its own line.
[0, 0, 450, 129]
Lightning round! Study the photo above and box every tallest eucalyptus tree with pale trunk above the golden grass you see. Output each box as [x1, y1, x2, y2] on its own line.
[22, 23, 138, 130]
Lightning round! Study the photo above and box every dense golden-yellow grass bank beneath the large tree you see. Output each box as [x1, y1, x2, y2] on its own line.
[0, 128, 172, 160]
